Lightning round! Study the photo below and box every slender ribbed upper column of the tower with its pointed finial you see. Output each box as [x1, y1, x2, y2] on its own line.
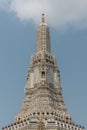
[36, 14, 51, 53]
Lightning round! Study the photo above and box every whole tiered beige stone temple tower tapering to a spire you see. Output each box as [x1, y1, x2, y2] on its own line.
[2, 14, 84, 130]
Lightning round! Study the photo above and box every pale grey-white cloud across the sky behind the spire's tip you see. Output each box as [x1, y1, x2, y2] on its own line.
[0, 0, 87, 28]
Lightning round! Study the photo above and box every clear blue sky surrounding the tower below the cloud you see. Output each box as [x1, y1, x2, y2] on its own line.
[0, 0, 87, 129]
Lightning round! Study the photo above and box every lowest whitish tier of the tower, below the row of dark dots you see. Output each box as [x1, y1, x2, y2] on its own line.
[2, 115, 84, 130]
